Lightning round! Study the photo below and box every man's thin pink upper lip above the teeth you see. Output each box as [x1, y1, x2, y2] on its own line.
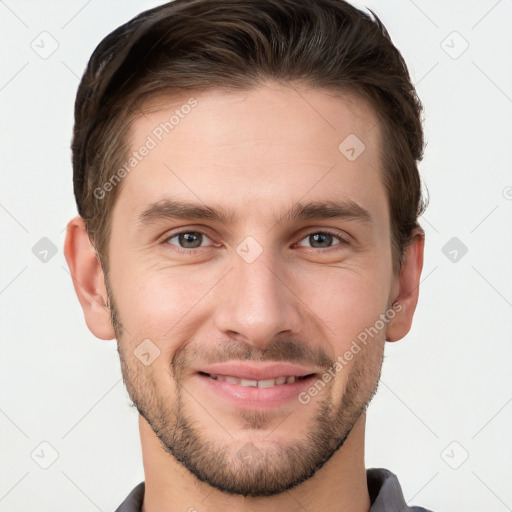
[198, 361, 316, 380]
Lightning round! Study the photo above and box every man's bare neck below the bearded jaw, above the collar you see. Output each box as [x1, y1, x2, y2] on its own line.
[139, 413, 370, 512]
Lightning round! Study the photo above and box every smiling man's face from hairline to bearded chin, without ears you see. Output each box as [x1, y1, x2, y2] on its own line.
[108, 83, 397, 496]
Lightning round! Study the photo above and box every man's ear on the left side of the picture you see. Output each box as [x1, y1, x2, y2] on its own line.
[64, 216, 115, 340]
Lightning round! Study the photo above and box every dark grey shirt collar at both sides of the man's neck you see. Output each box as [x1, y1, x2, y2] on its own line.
[116, 468, 431, 512]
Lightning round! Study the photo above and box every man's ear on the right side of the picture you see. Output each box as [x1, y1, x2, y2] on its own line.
[386, 228, 425, 341]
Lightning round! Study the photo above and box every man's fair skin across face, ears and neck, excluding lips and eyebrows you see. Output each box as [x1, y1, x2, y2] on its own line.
[65, 82, 424, 512]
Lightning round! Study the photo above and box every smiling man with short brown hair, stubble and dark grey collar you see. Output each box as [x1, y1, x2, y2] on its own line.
[65, 0, 425, 512]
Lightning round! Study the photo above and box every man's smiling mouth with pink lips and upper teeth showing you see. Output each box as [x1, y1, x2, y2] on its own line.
[195, 362, 319, 410]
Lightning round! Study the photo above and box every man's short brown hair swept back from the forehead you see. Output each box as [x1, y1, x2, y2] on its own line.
[71, 0, 425, 272]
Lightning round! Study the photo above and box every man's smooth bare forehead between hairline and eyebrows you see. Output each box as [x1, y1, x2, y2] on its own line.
[116, 82, 385, 222]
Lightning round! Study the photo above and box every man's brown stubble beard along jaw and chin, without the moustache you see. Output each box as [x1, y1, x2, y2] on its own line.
[107, 280, 383, 497]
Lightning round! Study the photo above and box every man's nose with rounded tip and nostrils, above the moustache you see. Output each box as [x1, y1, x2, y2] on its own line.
[215, 252, 301, 350]
